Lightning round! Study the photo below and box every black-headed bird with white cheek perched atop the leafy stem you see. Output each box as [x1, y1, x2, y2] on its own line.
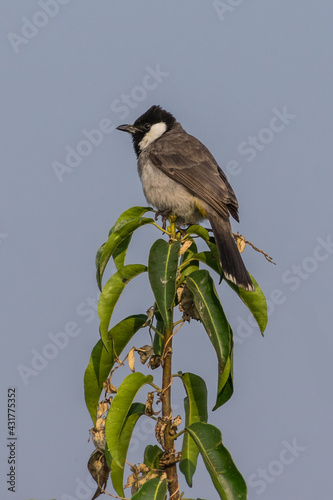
[117, 105, 254, 291]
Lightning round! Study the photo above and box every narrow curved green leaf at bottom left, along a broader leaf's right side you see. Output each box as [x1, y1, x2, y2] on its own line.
[111, 403, 146, 497]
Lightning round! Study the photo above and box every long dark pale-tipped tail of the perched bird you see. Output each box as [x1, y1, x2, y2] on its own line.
[207, 214, 254, 291]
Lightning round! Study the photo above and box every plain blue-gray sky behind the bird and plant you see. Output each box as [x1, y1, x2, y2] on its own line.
[0, 0, 333, 500]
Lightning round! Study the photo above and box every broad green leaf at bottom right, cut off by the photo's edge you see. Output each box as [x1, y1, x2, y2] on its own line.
[187, 422, 246, 500]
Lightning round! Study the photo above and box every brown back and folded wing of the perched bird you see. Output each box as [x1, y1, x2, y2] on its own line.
[149, 126, 239, 221]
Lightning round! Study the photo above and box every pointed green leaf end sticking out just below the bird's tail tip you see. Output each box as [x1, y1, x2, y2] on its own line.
[226, 275, 268, 334]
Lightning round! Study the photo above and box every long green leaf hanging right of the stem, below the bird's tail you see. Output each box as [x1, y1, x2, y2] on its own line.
[186, 270, 232, 406]
